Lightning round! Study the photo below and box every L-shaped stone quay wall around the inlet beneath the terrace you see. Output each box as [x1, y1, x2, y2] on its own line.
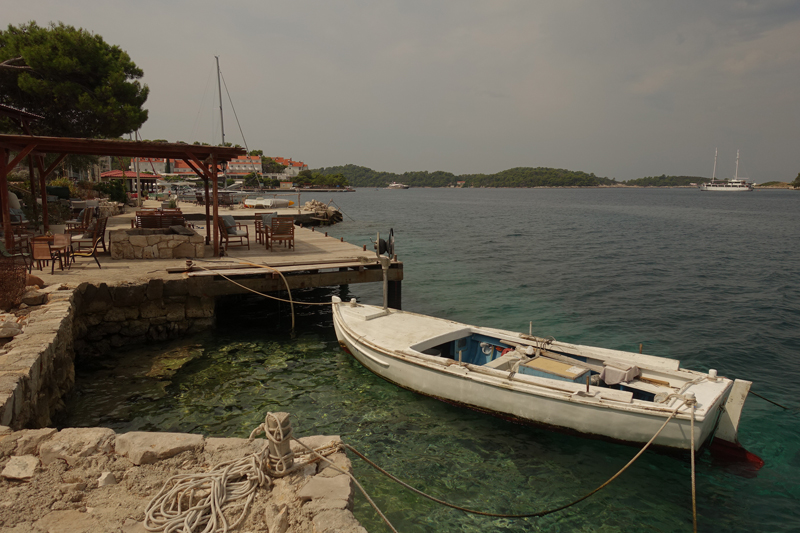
[0, 278, 215, 429]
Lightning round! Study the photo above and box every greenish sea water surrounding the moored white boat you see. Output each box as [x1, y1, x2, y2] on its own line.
[63, 189, 800, 532]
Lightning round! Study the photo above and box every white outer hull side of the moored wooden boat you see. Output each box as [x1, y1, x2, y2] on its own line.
[334, 305, 727, 450]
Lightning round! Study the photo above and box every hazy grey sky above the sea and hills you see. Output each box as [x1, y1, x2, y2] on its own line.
[6, 0, 800, 183]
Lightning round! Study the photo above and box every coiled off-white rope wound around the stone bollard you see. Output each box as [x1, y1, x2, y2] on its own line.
[144, 413, 340, 533]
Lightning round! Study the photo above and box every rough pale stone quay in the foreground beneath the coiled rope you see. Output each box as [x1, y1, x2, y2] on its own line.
[0, 427, 366, 533]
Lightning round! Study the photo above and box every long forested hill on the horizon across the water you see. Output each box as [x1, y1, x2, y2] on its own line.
[314, 165, 618, 187]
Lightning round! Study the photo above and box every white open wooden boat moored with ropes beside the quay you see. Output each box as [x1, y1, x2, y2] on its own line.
[332, 297, 751, 450]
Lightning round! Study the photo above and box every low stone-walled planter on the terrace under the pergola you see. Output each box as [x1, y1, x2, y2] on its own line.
[109, 226, 205, 259]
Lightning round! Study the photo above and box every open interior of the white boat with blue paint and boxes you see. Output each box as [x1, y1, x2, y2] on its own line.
[410, 328, 694, 402]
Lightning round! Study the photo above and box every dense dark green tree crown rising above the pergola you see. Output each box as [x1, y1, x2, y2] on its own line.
[0, 22, 149, 137]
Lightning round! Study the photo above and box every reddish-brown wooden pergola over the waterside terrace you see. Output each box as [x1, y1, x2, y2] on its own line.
[0, 134, 246, 256]
